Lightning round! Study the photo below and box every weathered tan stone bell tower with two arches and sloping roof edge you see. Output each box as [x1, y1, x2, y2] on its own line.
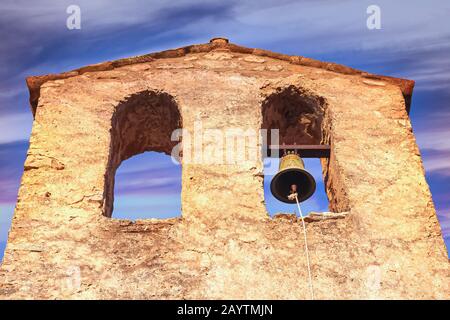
[0, 38, 450, 299]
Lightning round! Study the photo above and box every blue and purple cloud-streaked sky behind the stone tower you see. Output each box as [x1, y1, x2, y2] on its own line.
[0, 0, 450, 255]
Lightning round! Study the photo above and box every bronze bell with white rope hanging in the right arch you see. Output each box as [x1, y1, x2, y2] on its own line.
[270, 152, 316, 203]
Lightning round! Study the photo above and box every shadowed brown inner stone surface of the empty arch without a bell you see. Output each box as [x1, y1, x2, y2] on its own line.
[104, 91, 182, 217]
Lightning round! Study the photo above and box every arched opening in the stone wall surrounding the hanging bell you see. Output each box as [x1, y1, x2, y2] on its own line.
[262, 86, 348, 213]
